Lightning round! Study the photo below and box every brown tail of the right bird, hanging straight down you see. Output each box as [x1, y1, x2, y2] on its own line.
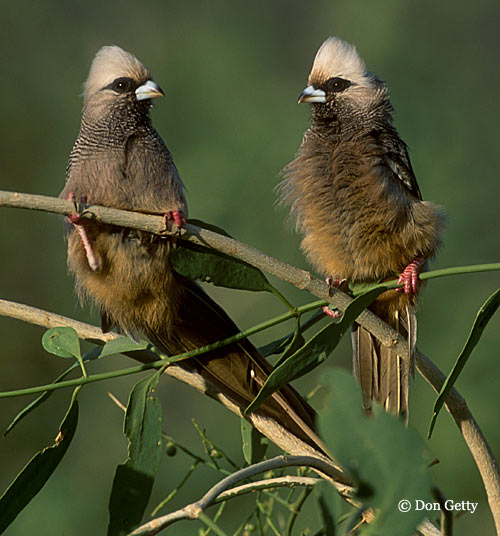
[352, 306, 417, 420]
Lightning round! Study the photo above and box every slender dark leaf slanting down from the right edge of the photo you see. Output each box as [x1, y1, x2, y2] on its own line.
[427, 289, 500, 439]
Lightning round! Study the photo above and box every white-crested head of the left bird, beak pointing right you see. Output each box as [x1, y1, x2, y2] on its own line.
[83, 46, 165, 120]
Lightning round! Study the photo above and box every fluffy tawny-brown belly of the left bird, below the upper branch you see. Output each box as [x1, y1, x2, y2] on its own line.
[68, 229, 179, 333]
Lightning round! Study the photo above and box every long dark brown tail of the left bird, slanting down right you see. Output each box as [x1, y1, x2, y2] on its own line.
[143, 274, 326, 453]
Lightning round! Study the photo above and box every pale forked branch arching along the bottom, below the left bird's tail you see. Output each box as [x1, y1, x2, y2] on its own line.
[129, 456, 333, 536]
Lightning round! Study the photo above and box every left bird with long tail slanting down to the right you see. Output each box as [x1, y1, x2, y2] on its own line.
[59, 45, 324, 451]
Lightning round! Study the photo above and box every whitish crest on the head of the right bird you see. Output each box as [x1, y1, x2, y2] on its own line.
[309, 37, 374, 87]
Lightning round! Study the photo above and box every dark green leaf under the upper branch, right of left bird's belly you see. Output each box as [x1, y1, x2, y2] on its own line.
[170, 242, 274, 292]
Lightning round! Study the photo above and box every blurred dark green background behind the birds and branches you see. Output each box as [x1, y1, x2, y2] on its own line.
[0, 0, 500, 536]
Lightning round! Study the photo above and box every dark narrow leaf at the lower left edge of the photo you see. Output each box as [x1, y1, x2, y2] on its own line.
[0, 389, 79, 534]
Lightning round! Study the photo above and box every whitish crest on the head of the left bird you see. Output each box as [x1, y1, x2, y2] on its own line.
[83, 45, 151, 101]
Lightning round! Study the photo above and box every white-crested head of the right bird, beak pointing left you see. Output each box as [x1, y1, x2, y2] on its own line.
[298, 37, 387, 121]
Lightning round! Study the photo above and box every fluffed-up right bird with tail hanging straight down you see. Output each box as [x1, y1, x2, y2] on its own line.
[278, 37, 445, 420]
